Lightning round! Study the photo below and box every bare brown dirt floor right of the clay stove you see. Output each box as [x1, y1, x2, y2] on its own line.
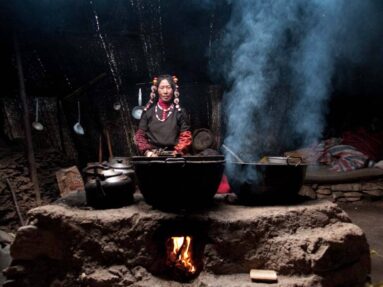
[339, 200, 383, 286]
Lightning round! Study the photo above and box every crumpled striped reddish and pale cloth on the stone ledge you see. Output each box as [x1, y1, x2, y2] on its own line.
[319, 145, 368, 172]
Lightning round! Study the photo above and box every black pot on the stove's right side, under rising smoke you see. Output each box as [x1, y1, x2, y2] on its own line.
[226, 163, 307, 205]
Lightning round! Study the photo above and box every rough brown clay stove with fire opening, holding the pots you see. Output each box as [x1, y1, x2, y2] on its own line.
[8, 199, 370, 286]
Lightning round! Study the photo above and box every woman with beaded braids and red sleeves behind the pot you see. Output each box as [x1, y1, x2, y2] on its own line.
[134, 75, 192, 157]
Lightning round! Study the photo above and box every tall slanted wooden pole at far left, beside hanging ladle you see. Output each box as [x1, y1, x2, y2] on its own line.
[14, 35, 41, 205]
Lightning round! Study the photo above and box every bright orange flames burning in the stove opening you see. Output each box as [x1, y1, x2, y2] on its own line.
[168, 236, 196, 274]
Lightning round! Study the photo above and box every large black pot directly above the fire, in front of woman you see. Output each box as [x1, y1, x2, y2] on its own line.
[132, 156, 225, 210]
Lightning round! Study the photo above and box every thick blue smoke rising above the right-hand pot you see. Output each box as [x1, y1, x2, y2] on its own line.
[212, 0, 378, 166]
